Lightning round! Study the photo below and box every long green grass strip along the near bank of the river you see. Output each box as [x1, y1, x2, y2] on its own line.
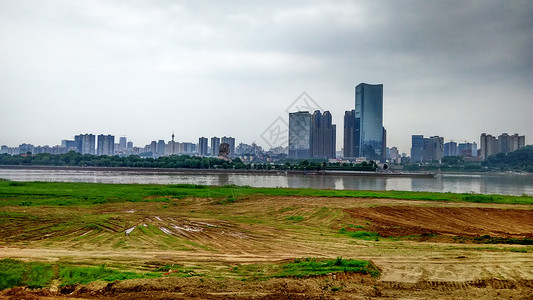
[0, 181, 533, 206]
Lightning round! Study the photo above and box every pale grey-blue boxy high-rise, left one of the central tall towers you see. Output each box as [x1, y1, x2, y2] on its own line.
[289, 111, 312, 159]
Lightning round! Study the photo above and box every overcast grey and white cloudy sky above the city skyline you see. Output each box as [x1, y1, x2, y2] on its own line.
[0, 0, 533, 153]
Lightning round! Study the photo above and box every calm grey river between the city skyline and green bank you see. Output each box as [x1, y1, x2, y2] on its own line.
[0, 168, 533, 195]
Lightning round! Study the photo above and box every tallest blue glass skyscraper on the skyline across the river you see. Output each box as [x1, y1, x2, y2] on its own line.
[355, 83, 386, 161]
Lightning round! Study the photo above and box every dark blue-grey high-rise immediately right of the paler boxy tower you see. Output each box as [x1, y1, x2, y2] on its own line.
[310, 110, 337, 158]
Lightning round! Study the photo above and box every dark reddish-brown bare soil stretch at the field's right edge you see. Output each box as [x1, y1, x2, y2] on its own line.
[348, 206, 533, 239]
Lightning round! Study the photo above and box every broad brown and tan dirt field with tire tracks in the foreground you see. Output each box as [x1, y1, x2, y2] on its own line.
[0, 196, 533, 299]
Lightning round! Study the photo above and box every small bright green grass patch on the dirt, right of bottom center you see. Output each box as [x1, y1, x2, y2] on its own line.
[274, 257, 380, 278]
